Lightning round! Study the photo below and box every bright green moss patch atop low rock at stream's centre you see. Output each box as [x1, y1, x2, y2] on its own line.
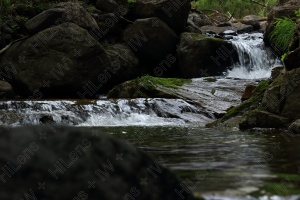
[136, 76, 191, 89]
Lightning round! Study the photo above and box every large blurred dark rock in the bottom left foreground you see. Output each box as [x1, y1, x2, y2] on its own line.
[0, 126, 194, 200]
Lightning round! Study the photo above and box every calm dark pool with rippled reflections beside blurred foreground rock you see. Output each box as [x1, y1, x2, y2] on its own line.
[93, 127, 300, 199]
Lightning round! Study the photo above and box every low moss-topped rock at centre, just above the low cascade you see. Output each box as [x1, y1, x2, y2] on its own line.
[107, 76, 191, 98]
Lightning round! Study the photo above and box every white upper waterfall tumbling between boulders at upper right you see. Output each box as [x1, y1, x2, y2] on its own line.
[226, 33, 281, 79]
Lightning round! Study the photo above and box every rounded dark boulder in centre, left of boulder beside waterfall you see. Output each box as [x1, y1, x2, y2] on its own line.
[123, 17, 178, 63]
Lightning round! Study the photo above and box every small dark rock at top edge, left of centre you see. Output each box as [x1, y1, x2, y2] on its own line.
[96, 0, 128, 15]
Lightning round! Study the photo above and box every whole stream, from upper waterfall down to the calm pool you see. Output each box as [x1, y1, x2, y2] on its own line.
[0, 34, 300, 200]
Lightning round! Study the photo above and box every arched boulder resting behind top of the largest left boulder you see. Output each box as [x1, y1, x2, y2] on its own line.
[25, 2, 99, 33]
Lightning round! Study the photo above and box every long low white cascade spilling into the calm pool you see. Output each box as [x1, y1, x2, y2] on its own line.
[0, 98, 214, 126]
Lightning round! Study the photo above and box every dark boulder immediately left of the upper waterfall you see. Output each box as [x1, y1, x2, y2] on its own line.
[177, 33, 238, 78]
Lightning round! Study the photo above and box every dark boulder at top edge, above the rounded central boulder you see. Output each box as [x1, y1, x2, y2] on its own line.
[134, 0, 191, 33]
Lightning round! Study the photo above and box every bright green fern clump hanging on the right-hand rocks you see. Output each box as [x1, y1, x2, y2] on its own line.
[270, 17, 296, 53]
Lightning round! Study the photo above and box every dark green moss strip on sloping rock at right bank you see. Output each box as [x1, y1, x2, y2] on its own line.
[221, 80, 271, 121]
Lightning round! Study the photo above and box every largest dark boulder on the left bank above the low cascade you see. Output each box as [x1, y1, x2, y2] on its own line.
[0, 23, 114, 98]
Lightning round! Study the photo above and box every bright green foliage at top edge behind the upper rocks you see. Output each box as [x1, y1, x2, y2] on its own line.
[192, 0, 277, 18]
